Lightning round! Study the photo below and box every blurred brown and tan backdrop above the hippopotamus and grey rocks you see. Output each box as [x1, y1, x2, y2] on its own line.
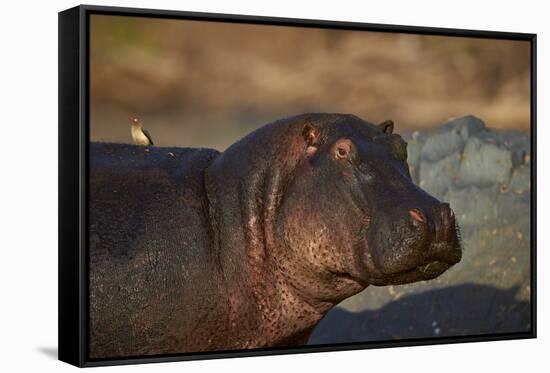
[90, 15, 530, 150]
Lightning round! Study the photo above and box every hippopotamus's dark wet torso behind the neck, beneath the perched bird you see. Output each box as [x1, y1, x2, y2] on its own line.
[89, 143, 223, 357]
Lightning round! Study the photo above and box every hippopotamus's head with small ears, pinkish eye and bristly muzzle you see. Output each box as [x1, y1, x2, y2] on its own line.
[205, 114, 462, 308]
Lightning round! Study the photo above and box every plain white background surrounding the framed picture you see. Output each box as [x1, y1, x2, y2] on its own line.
[0, 0, 550, 373]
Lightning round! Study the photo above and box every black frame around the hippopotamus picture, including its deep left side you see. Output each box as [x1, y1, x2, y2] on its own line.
[58, 5, 537, 367]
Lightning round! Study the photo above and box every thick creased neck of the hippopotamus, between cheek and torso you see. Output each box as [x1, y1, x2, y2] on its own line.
[205, 115, 340, 347]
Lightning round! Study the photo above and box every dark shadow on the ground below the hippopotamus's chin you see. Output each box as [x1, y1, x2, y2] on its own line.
[308, 284, 531, 344]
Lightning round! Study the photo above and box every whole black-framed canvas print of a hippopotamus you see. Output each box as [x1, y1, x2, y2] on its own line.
[59, 6, 536, 367]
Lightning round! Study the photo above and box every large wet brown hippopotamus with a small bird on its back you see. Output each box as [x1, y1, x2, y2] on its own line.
[89, 113, 462, 358]
